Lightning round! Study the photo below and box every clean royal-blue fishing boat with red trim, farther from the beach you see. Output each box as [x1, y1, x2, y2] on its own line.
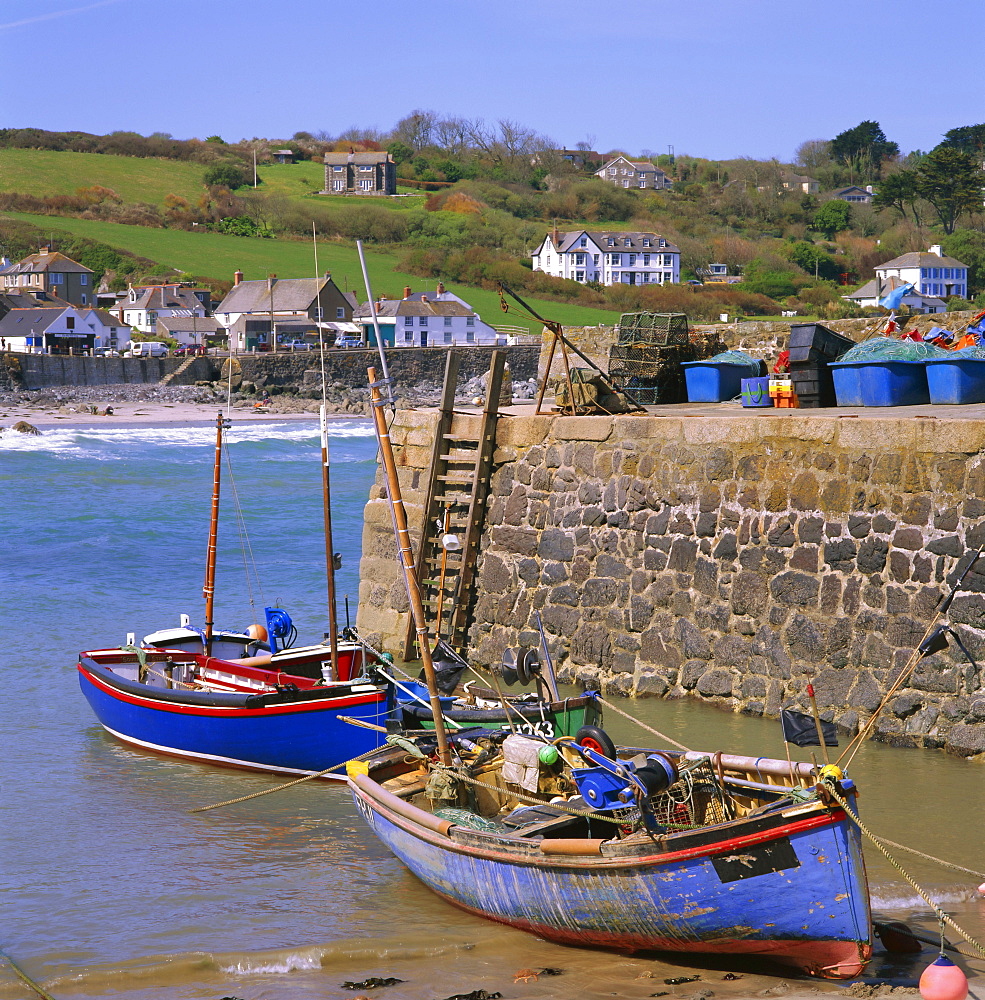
[78, 647, 393, 779]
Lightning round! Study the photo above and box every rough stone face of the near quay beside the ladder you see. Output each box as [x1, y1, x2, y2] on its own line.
[359, 411, 985, 755]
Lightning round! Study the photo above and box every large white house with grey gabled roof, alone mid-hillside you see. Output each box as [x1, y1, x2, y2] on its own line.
[533, 229, 681, 285]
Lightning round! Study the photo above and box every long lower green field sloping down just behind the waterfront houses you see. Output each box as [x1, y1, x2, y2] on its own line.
[4, 211, 618, 330]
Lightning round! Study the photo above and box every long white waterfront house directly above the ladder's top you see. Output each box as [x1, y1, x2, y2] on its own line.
[352, 282, 506, 347]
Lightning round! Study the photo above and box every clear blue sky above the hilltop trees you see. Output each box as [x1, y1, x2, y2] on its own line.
[0, 0, 985, 160]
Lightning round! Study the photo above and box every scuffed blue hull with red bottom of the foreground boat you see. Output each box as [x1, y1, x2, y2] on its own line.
[350, 778, 871, 978]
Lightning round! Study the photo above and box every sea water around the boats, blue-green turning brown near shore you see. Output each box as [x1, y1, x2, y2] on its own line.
[0, 420, 985, 1000]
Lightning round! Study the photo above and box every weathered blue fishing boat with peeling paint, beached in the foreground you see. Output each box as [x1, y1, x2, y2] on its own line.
[349, 731, 872, 979]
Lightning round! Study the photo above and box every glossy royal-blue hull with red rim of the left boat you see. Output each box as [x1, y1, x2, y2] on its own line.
[79, 663, 387, 777]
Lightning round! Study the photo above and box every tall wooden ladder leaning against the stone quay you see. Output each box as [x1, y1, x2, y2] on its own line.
[404, 351, 506, 660]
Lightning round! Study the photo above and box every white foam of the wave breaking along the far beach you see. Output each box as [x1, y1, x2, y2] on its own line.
[0, 419, 373, 461]
